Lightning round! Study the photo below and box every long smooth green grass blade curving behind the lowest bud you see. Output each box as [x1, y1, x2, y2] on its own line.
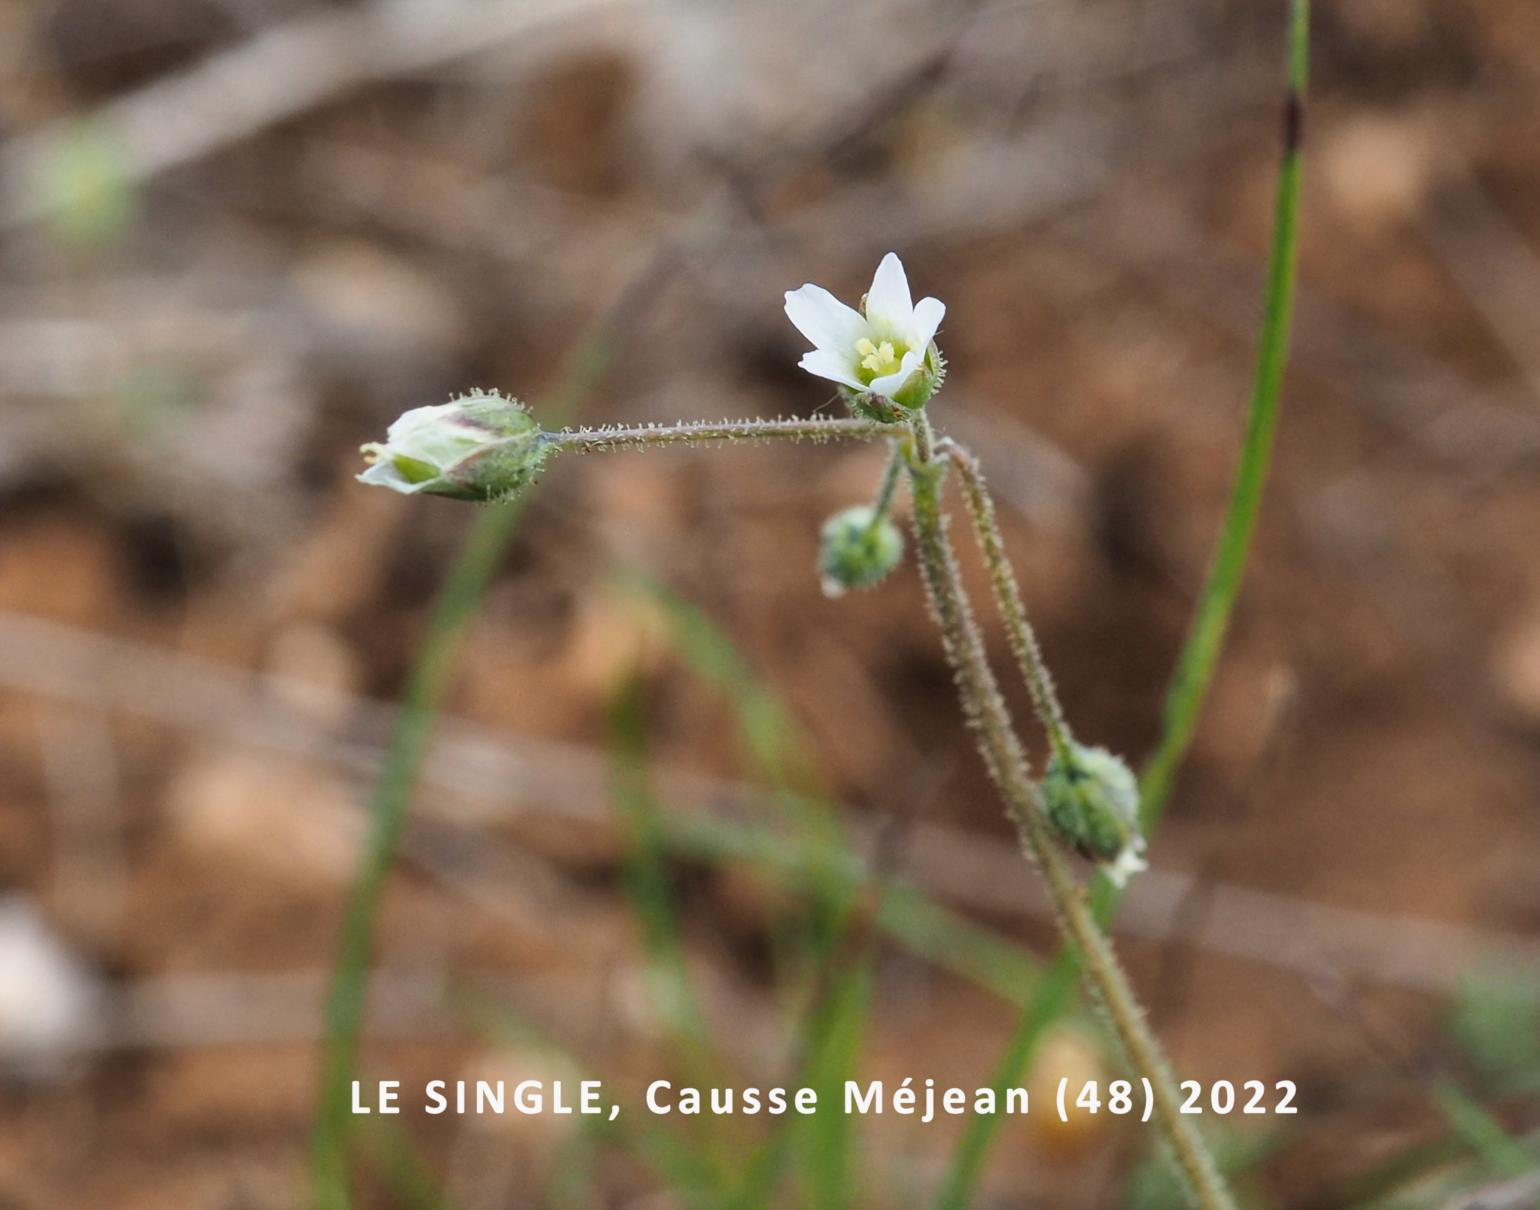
[935, 0, 1311, 1210]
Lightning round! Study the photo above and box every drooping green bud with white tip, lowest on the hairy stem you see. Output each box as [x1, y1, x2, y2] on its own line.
[1043, 740, 1144, 887]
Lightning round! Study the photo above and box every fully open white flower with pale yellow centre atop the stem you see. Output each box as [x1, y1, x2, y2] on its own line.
[785, 252, 947, 408]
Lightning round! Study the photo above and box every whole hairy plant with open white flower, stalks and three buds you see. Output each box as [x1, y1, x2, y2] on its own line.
[359, 252, 1230, 1207]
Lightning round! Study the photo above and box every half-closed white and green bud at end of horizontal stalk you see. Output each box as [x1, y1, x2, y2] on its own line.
[357, 393, 554, 500]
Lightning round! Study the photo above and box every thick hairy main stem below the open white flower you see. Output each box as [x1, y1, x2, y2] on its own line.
[909, 413, 1234, 1210]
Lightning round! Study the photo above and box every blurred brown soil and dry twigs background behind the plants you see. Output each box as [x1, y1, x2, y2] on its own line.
[0, 0, 1540, 1210]
